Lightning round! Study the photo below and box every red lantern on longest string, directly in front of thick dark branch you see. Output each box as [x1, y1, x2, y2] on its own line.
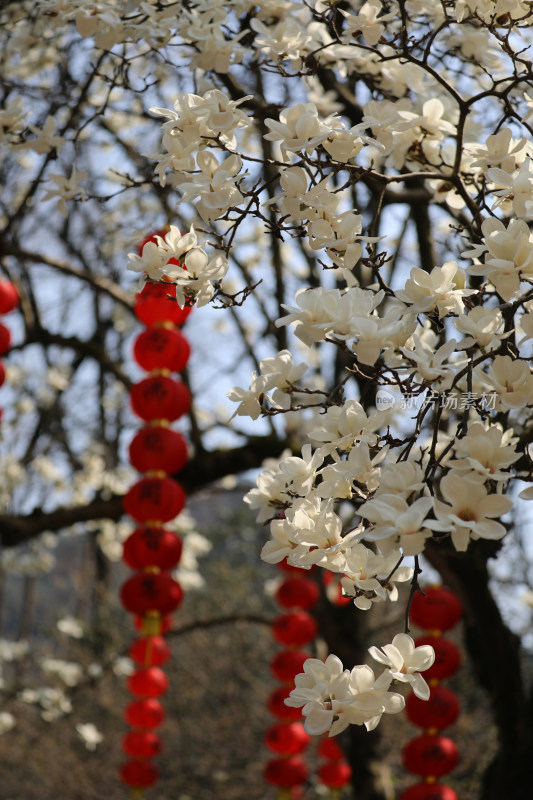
[122, 478, 185, 522]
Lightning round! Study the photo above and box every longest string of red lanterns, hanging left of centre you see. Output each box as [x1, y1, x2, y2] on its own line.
[120, 234, 192, 796]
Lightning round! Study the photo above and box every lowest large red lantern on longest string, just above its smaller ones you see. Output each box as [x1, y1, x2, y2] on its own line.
[120, 572, 183, 614]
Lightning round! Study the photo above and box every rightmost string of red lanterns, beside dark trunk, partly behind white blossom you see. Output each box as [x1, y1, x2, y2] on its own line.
[400, 586, 463, 800]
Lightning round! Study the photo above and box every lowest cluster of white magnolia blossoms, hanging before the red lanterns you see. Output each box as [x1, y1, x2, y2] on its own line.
[285, 633, 435, 736]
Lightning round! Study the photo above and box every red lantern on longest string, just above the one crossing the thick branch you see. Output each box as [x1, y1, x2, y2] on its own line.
[129, 425, 188, 475]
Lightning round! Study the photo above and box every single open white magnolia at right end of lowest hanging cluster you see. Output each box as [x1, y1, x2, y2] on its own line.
[368, 633, 435, 700]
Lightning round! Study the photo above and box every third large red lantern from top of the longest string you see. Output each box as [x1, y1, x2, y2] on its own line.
[130, 375, 191, 422]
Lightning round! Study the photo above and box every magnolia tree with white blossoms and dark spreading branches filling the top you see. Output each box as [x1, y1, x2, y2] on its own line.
[0, 0, 533, 800]
